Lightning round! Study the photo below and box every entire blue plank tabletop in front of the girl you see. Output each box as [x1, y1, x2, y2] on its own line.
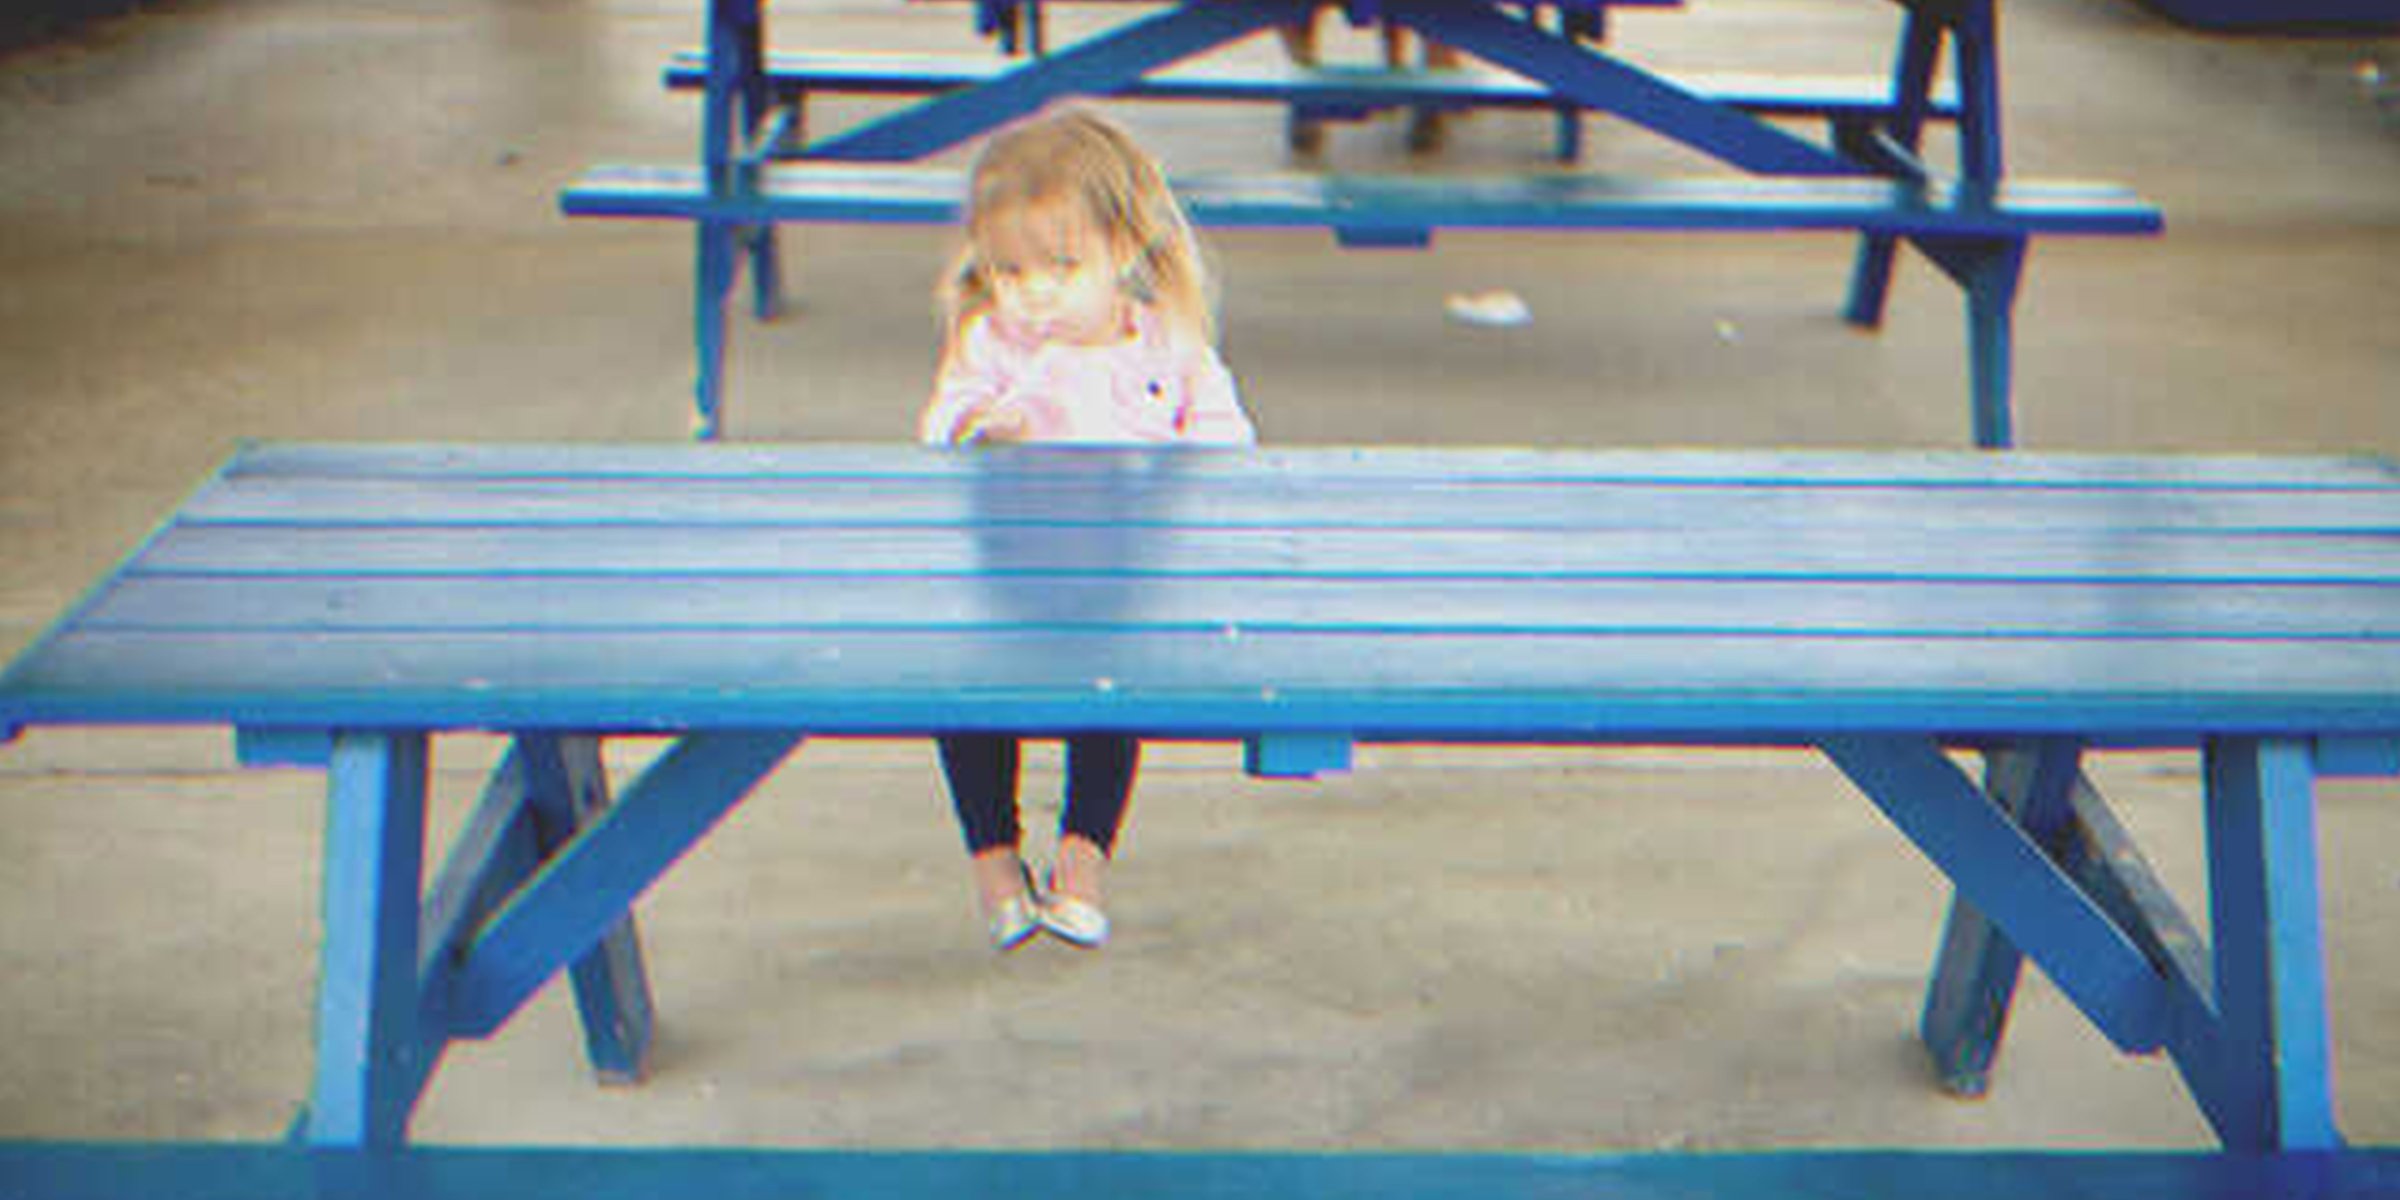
[0, 446, 2400, 744]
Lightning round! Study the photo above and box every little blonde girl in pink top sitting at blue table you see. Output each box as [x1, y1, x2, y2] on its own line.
[917, 110, 1258, 950]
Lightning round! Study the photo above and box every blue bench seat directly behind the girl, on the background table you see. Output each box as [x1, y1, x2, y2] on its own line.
[559, 163, 2160, 446]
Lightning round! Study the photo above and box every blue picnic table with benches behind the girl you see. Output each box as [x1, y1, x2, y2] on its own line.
[559, 0, 2160, 446]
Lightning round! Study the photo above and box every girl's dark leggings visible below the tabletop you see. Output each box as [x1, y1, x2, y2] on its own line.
[936, 734, 1142, 854]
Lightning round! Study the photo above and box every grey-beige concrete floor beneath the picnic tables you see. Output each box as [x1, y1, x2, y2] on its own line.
[0, 0, 2400, 1150]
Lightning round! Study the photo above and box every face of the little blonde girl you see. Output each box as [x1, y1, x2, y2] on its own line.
[982, 202, 1128, 346]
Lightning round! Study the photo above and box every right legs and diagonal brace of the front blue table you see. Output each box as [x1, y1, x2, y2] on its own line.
[1826, 739, 2340, 1152]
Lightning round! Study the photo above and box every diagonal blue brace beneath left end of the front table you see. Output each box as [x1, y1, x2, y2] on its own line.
[449, 732, 799, 1037]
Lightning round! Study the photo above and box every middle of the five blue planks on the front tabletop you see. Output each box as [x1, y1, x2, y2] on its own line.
[110, 523, 2400, 583]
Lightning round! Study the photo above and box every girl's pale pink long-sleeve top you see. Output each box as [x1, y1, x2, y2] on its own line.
[917, 305, 1258, 446]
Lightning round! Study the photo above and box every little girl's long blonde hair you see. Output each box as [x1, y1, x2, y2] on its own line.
[938, 108, 1217, 346]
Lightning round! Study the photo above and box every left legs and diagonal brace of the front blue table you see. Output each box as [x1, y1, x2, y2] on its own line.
[295, 732, 799, 1150]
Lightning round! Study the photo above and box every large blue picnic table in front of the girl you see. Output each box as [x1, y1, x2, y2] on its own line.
[0, 444, 2400, 1171]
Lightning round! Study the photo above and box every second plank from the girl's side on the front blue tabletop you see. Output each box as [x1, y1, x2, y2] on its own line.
[185, 472, 2400, 530]
